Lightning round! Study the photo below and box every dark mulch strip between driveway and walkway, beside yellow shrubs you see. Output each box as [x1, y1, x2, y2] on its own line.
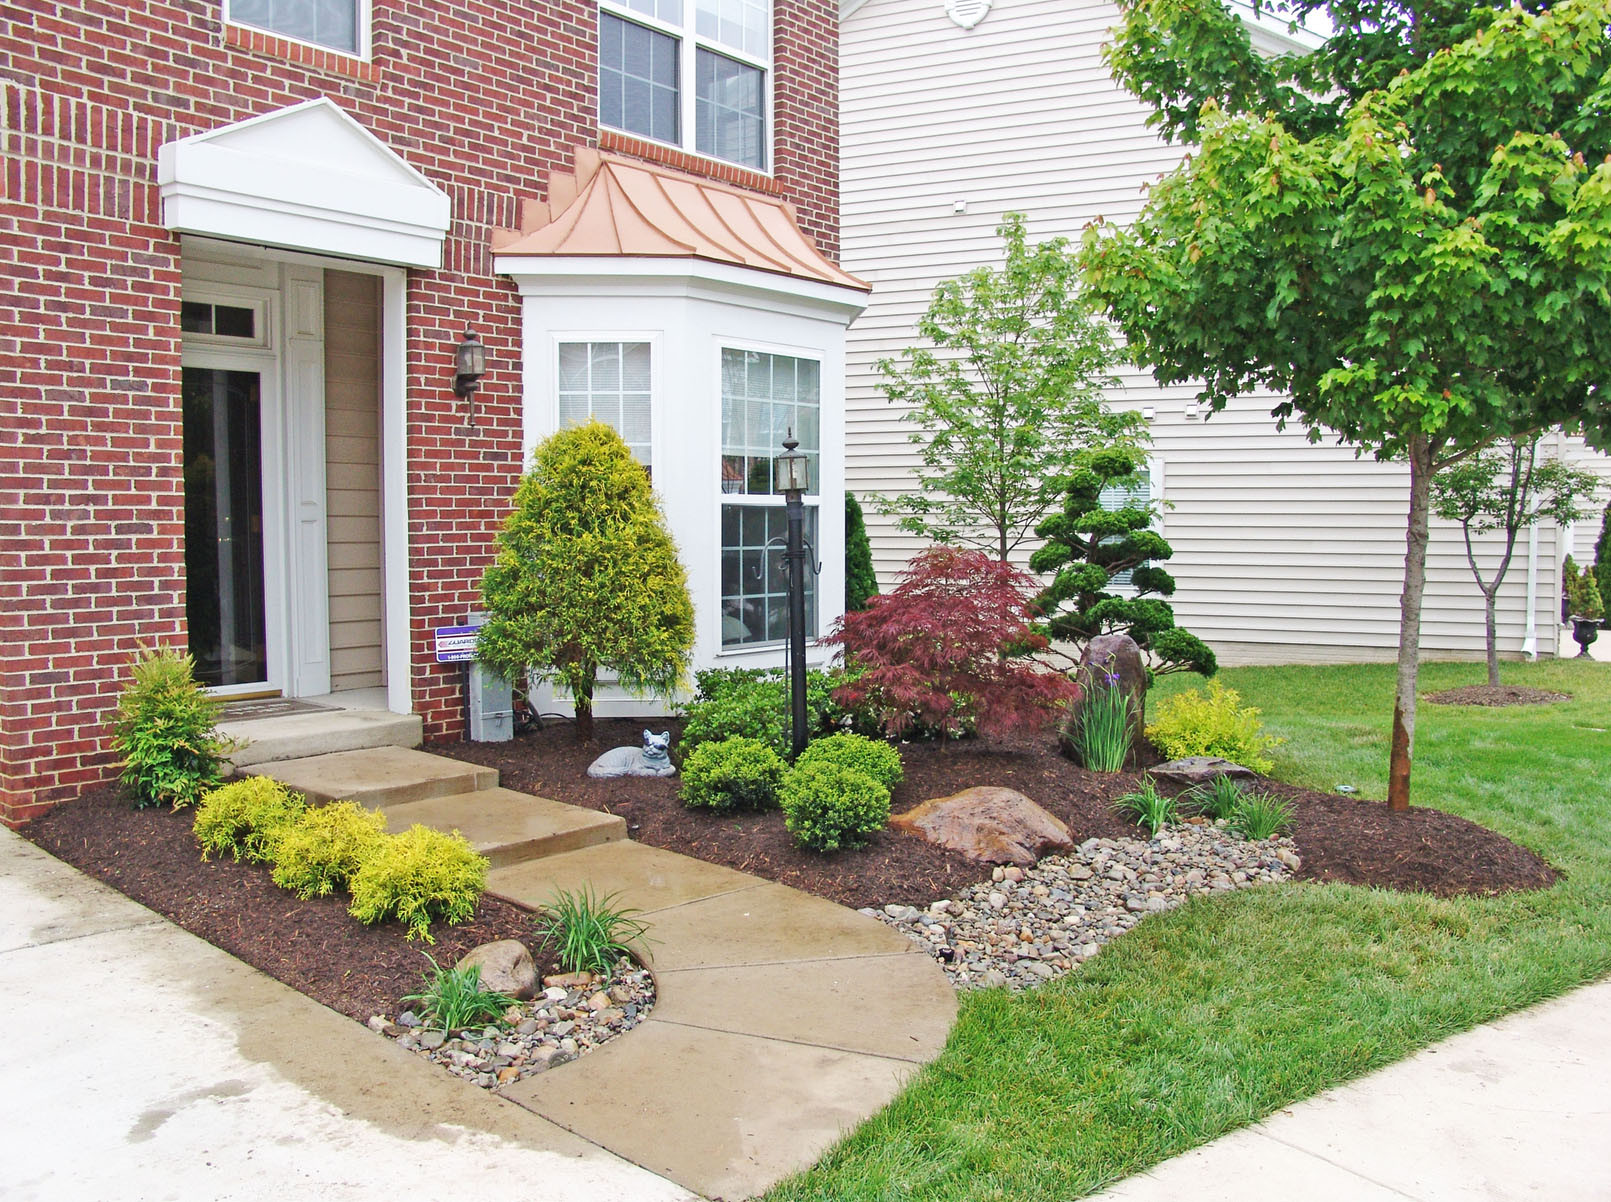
[23, 788, 559, 1022]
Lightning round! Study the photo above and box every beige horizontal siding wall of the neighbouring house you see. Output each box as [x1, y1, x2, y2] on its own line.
[839, 0, 1611, 662]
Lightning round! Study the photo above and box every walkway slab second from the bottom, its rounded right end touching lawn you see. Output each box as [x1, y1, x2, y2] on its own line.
[654, 955, 957, 1063]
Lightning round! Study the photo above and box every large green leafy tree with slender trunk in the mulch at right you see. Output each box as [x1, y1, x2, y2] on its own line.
[1081, 0, 1611, 807]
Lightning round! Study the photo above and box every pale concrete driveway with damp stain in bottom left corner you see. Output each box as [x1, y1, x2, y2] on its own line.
[0, 827, 693, 1202]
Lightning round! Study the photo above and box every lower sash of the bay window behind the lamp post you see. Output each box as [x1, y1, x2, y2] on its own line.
[722, 504, 817, 646]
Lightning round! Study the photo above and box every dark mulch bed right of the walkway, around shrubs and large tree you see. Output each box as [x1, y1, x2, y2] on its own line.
[430, 720, 1556, 909]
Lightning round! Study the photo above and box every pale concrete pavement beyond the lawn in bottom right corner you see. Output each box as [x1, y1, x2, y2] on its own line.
[1099, 980, 1611, 1202]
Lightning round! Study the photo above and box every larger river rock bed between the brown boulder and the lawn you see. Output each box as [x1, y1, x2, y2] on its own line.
[862, 822, 1302, 989]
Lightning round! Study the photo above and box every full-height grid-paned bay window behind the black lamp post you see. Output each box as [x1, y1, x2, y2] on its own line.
[722, 348, 822, 646]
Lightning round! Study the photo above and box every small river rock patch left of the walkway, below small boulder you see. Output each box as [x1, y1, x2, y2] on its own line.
[369, 959, 654, 1089]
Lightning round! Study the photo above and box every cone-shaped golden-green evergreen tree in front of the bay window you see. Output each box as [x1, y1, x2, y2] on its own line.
[475, 422, 694, 741]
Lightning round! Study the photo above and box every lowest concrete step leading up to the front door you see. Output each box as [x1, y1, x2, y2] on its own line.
[383, 788, 627, 868]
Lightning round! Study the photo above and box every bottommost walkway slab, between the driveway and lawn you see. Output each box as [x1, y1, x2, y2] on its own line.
[504, 1015, 917, 1200]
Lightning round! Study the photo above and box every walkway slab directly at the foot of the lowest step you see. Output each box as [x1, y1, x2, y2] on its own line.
[487, 843, 762, 914]
